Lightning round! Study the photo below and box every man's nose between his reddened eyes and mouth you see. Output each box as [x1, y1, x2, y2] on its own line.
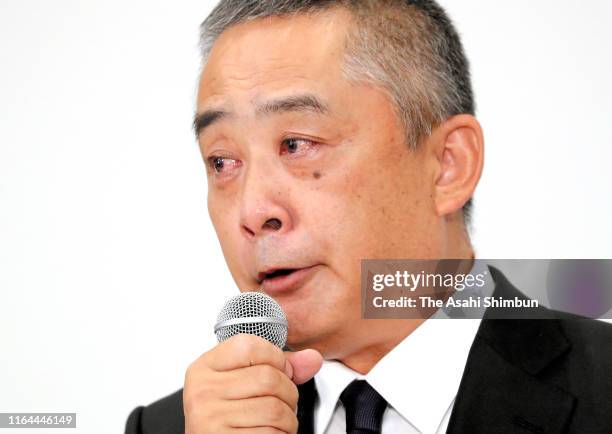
[240, 166, 293, 239]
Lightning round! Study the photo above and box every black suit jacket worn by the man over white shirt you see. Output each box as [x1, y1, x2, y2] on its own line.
[126, 267, 612, 434]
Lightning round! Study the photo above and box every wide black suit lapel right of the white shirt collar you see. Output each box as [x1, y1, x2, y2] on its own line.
[447, 267, 575, 433]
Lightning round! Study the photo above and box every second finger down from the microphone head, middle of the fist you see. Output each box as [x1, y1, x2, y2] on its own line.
[215, 365, 299, 410]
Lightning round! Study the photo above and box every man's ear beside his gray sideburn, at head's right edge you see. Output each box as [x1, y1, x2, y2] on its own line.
[433, 114, 484, 216]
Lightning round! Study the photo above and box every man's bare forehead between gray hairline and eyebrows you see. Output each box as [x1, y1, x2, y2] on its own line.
[198, 8, 350, 108]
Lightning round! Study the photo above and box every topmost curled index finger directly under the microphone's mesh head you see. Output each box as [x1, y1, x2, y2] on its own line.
[202, 334, 286, 371]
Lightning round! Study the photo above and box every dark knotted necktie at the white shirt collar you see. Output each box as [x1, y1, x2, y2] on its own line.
[340, 380, 387, 434]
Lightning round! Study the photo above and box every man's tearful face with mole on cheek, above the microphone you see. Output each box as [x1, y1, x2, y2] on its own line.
[198, 10, 440, 356]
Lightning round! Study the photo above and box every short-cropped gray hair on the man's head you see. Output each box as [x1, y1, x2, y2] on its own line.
[200, 0, 475, 221]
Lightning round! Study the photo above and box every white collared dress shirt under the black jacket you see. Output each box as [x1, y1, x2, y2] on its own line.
[314, 262, 492, 434]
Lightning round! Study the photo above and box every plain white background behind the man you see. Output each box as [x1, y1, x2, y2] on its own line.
[0, 0, 612, 434]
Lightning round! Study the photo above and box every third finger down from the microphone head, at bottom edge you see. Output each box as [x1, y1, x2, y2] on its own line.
[226, 396, 298, 433]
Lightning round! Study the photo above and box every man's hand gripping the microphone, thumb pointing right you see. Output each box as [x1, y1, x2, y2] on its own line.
[183, 334, 323, 434]
